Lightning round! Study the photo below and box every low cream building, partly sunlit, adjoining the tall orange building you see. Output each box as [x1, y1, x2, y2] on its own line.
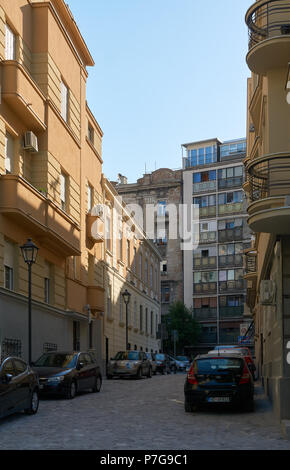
[103, 178, 161, 360]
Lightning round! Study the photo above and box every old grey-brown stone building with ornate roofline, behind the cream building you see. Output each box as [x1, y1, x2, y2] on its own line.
[116, 168, 183, 315]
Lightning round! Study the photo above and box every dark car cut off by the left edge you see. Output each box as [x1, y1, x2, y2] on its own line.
[0, 357, 39, 418]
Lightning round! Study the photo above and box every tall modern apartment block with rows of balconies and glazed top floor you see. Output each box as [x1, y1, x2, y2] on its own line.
[182, 139, 251, 351]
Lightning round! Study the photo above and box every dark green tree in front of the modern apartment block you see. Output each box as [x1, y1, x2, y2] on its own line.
[162, 301, 201, 354]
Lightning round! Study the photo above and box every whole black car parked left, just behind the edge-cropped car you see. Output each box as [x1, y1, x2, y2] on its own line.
[33, 352, 102, 399]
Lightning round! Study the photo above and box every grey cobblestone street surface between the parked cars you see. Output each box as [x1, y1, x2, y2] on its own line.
[0, 373, 290, 450]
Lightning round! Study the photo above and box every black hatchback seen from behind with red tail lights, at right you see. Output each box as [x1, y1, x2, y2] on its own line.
[184, 352, 254, 412]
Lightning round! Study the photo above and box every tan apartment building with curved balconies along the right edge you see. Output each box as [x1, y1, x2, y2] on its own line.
[244, 0, 290, 420]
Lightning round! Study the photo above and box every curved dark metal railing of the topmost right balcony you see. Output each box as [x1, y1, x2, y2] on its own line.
[246, 0, 290, 49]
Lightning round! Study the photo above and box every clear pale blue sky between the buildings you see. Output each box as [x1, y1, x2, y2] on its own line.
[66, 0, 253, 183]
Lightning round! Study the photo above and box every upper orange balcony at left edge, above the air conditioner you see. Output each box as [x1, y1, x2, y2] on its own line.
[1, 60, 46, 132]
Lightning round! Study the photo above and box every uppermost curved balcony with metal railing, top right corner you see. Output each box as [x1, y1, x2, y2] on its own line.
[246, 0, 290, 74]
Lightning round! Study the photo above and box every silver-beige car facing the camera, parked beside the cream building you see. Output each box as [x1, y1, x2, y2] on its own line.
[107, 351, 152, 379]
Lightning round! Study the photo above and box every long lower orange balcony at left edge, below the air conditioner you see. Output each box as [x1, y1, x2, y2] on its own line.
[0, 175, 81, 256]
